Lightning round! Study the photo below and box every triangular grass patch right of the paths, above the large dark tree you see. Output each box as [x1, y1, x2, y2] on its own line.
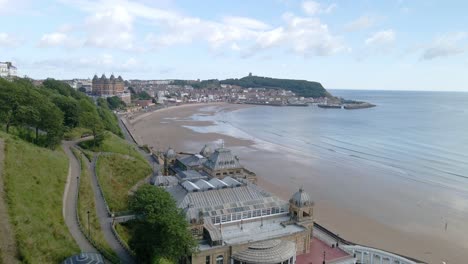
[96, 154, 151, 212]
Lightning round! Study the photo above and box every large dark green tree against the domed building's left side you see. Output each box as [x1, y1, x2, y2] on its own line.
[129, 185, 197, 263]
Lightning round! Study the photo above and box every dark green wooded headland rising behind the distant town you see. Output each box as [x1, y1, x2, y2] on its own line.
[220, 75, 332, 98]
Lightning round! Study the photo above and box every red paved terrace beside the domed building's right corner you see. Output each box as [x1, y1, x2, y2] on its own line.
[296, 237, 350, 264]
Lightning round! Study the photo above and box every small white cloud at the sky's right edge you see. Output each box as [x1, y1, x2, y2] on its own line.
[421, 32, 468, 60]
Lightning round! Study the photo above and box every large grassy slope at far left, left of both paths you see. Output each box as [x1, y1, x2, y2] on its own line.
[0, 132, 80, 263]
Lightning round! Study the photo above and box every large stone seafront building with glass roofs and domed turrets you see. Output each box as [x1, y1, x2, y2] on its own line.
[151, 145, 424, 264]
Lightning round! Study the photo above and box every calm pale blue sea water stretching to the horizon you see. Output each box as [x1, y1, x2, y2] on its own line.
[221, 90, 468, 193]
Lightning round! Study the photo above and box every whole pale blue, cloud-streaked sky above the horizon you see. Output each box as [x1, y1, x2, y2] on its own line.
[0, 0, 468, 91]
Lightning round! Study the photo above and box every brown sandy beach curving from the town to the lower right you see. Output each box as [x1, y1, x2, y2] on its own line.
[122, 103, 468, 263]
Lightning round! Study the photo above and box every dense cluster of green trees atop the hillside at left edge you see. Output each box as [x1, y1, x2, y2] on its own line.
[0, 78, 122, 148]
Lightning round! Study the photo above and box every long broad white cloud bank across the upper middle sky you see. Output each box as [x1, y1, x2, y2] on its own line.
[55, 0, 344, 56]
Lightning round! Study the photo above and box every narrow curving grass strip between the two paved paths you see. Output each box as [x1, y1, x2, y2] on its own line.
[72, 149, 118, 258]
